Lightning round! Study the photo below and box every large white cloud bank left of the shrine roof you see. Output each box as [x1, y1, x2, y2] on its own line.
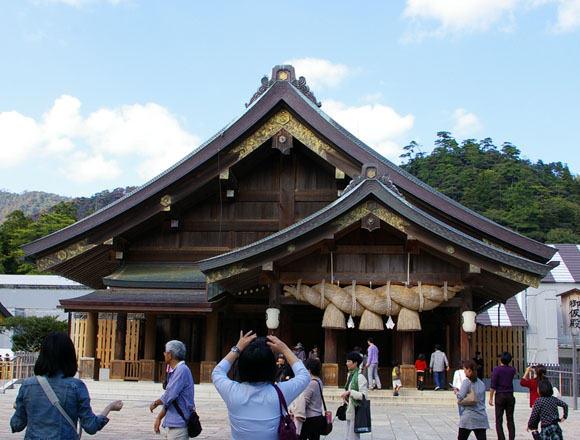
[0, 95, 200, 182]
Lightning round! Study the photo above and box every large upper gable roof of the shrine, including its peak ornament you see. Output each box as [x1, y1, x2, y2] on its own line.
[23, 66, 555, 266]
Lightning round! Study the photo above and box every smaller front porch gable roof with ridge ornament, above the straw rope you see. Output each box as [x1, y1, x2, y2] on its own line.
[198, 166, 552, 301]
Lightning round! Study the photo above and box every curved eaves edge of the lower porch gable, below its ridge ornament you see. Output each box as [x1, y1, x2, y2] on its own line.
[197, 179, 551, 284]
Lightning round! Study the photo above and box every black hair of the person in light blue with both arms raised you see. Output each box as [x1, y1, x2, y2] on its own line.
[238, 337, 276, 383]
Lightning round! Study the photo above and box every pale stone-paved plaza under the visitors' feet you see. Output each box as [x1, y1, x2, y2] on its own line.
[0, 385, 580, 440]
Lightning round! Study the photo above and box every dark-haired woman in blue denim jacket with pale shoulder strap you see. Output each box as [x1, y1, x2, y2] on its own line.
[10, 332, 123, 440]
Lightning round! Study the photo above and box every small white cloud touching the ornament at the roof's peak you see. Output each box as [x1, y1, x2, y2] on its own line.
[284, 58, 350, 91]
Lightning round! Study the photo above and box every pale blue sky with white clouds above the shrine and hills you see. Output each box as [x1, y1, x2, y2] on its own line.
[0, 0, 580, 196]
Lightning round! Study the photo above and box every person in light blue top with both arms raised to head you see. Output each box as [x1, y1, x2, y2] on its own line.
[211, 331, 310, 440]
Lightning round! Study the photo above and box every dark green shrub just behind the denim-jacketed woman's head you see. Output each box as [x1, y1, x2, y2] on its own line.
[0, 316, 67, 352]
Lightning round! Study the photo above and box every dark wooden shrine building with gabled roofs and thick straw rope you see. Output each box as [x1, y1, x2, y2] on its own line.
[23, 65, 556, 385]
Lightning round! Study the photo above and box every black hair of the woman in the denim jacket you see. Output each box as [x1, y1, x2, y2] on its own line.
[34, 332, 78, 377]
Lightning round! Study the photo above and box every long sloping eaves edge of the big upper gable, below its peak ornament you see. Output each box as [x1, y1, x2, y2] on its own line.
[22, 66, 555, 262]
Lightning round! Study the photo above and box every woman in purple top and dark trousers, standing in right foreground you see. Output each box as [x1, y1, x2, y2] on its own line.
[489, 351, 516, 440]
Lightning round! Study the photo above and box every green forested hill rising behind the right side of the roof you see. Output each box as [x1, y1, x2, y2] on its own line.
[401, 132, 580, 243]
